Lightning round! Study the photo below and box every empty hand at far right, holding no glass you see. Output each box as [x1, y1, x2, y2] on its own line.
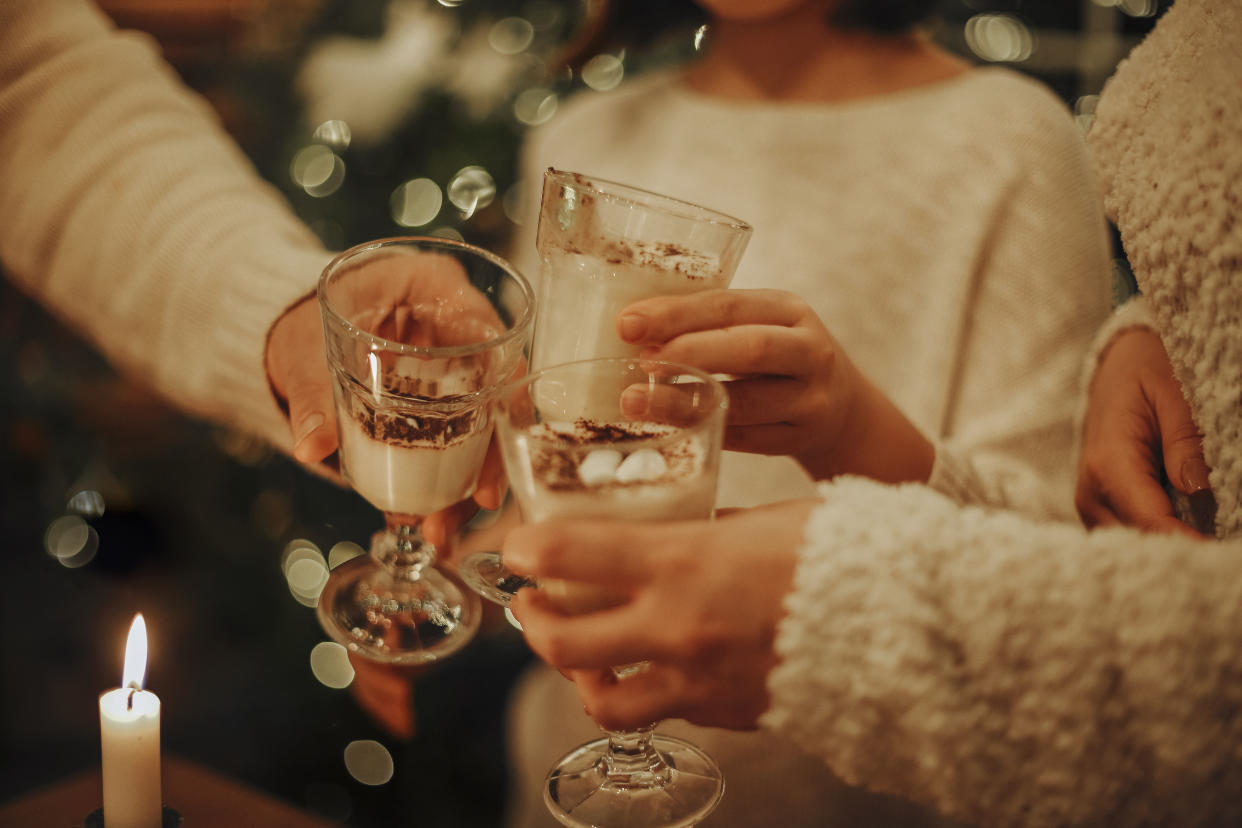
[1074, 328, 1208, 536]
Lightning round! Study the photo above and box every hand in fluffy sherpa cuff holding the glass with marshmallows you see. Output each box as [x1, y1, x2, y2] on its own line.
[503, 500, 817, 730]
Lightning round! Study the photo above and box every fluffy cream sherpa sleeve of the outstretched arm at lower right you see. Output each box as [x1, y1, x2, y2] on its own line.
[761, 478, 1242, 828]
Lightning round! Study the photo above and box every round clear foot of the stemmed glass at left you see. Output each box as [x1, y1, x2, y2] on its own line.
[315, 555, 482, 664]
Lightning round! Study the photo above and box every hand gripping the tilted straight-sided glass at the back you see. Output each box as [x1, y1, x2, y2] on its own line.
[617, 289, 934, 483]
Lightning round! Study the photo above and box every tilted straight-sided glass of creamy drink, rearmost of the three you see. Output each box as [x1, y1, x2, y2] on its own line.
[461, 169, 753, 603]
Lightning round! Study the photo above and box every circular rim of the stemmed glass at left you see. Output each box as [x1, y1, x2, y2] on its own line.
[315, 236, 535, 359]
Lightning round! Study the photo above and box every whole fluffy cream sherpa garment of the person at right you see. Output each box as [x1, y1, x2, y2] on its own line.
[763, 0, 1242, 828]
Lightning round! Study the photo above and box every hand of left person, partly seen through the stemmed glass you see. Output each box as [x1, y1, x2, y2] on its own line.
[265, 254, 505, 538]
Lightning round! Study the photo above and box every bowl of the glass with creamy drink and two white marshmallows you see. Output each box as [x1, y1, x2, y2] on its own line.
[484, 359, 727, 612]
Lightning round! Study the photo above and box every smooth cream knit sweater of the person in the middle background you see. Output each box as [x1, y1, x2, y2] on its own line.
[510, 53, 1109, 828]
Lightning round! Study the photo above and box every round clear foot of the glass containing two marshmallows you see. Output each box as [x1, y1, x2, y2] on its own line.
[544, 735, 724, 828]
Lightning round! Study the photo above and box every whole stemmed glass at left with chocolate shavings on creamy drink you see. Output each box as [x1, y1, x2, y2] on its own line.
[318, 237, 534, 664]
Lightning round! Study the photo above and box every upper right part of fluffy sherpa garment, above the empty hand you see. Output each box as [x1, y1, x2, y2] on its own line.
[1088, 0, 1242, 538]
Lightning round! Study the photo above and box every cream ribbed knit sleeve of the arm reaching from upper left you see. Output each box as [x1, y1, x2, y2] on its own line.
[0, 0, 328, 447]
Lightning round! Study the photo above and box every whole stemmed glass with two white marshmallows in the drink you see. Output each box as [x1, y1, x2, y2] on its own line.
[496, 359, 728, 828]
